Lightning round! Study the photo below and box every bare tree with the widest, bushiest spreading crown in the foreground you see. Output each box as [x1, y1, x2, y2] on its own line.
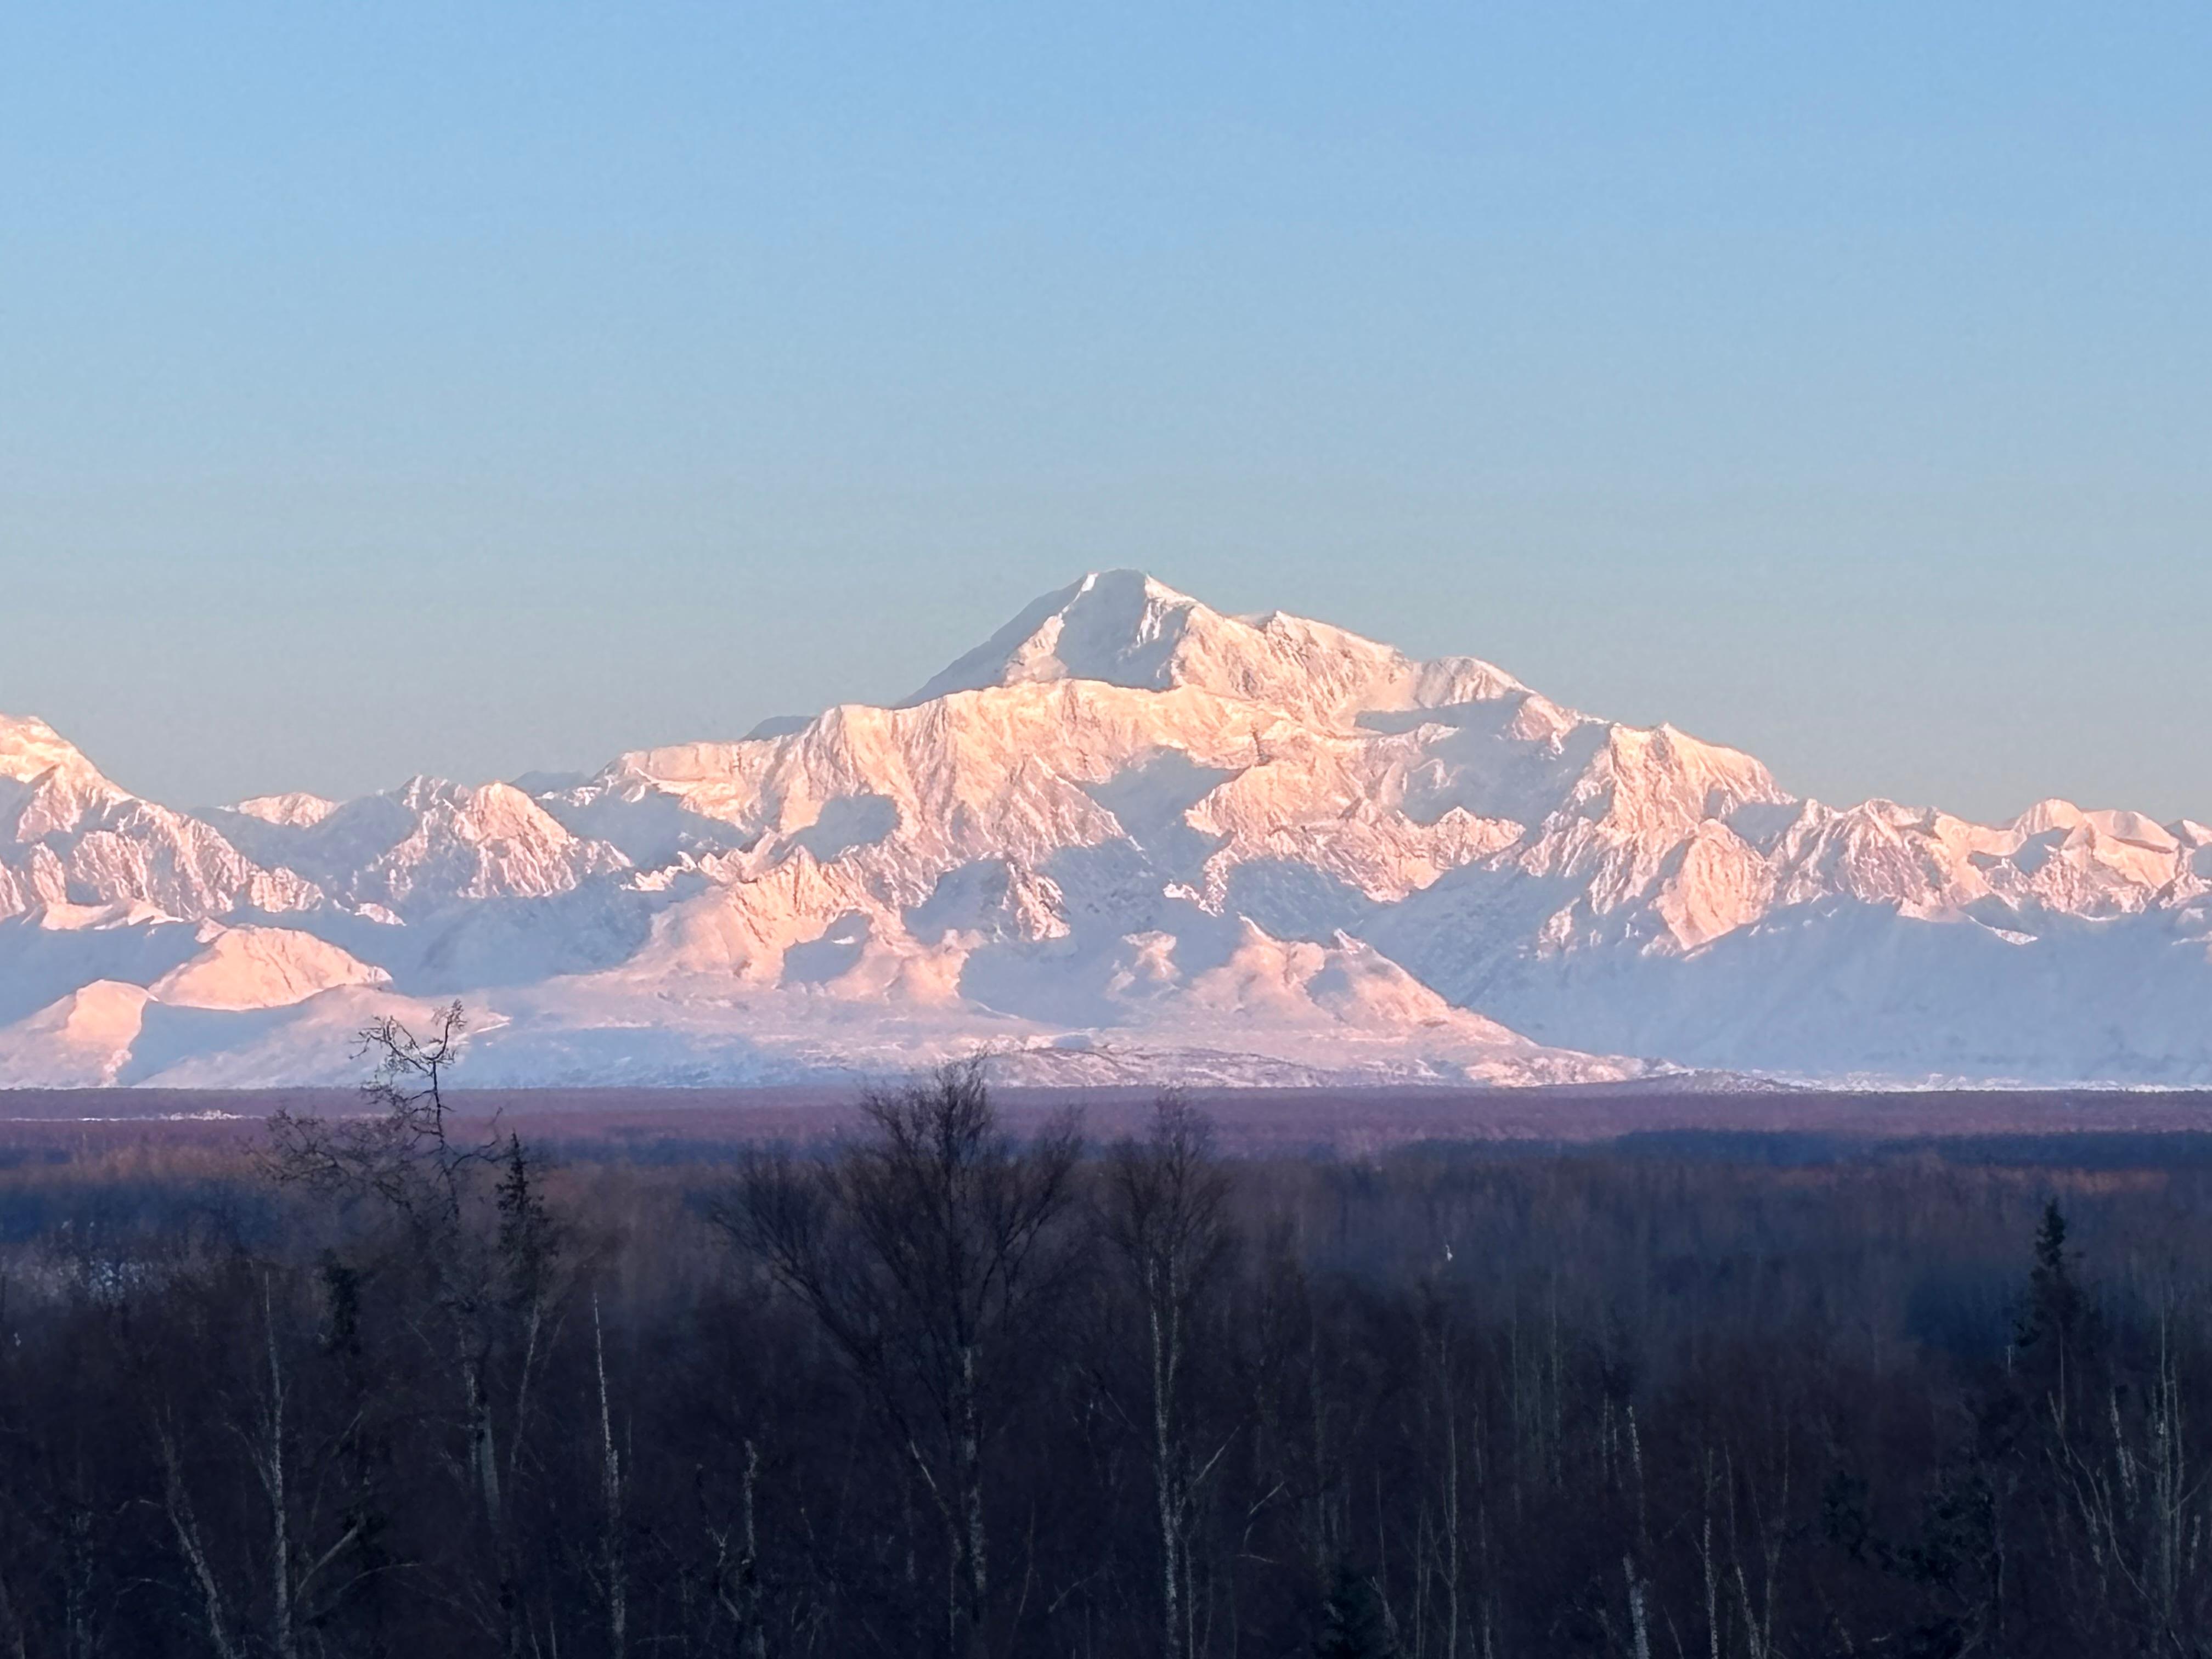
[719, 1059, 1082, 1659]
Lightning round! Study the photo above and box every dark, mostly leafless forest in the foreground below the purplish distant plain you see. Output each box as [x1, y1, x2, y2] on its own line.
[0, 1029, 2212, 1659]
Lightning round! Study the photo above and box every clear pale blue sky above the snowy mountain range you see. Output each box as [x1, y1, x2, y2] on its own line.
[0, 0, 2212, 819]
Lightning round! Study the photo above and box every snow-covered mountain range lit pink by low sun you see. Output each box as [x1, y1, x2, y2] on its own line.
[0, 571, 2212, 1084]
